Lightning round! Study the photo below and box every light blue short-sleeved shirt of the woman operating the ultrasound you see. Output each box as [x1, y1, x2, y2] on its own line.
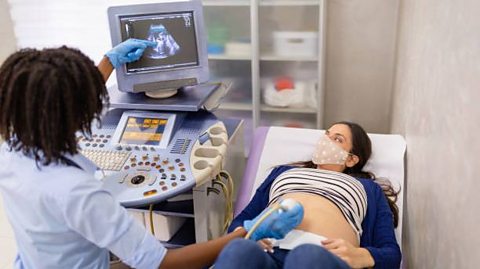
[0, 143, 167, 269]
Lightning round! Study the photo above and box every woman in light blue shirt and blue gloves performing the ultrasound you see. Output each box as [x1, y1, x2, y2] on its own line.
[0, 39, 302, 269]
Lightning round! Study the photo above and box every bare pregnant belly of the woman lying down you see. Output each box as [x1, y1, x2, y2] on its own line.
[282, 193, 359, 246]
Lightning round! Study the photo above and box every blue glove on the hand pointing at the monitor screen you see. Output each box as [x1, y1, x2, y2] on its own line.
[105, 38, 157, 68]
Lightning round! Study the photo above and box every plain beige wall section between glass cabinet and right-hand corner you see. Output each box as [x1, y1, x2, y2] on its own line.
[324, 0, 399, 133]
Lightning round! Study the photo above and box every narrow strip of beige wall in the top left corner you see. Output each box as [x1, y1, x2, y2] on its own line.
[0, 0, 16, 64]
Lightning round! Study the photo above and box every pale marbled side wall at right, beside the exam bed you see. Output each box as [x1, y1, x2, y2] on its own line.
[392, 0, 480, 268]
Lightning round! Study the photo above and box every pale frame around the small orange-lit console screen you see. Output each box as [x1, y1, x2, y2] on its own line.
[112, 111, 176, 149]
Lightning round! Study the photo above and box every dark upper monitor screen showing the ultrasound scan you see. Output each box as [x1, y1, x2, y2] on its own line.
[120, 12, 199, 73]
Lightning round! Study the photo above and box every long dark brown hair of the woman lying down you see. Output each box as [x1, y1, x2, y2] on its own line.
[291, 121, 400, 227]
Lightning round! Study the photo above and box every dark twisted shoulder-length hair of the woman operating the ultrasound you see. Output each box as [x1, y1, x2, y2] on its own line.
[0, 46, 108, 165]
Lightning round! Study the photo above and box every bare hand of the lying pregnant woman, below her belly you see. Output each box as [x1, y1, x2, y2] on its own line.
[322, 239, 375, 268]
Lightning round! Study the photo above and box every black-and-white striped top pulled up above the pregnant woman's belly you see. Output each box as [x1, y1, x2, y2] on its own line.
[269, 168, 367, 238]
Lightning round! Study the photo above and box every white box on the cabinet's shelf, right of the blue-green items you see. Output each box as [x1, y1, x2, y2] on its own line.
[273, 31, 318, 57]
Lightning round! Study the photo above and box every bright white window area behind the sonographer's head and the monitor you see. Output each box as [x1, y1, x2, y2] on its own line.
[7, 0, 180, 62]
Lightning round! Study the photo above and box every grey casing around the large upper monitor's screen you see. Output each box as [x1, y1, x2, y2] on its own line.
[108, 0, 209, 92]
